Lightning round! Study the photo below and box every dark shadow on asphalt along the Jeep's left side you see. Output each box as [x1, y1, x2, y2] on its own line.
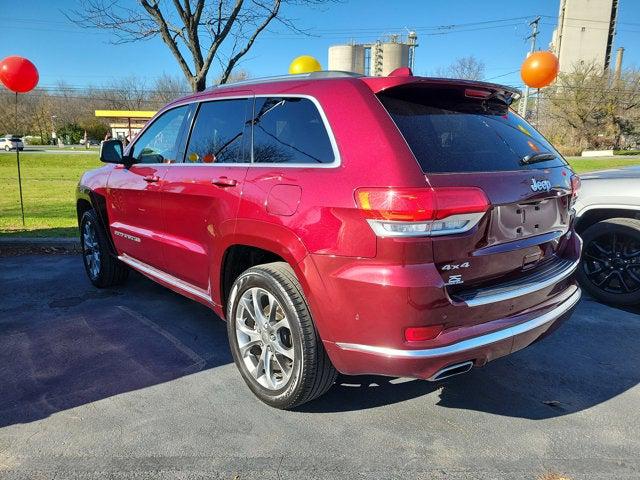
[0, 255, 232, 427]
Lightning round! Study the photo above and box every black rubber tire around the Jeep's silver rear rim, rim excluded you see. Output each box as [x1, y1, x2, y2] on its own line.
[227, 262, 337, 410]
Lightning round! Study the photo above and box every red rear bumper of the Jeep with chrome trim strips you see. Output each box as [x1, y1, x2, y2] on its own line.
[301, 234, 581, 379]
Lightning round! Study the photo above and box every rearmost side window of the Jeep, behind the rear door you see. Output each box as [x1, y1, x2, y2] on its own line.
[252, 97, 334, 164]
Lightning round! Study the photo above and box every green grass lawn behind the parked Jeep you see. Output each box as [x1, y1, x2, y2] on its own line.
[0, 151, 640, 237]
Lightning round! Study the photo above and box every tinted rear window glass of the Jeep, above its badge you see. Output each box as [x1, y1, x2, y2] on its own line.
[379, 87, 566, 173]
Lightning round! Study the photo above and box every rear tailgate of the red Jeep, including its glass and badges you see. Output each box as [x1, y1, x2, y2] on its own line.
[378, 81, 573, 298]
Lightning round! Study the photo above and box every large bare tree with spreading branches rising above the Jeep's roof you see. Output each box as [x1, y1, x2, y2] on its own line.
[68, 0, 326, 91]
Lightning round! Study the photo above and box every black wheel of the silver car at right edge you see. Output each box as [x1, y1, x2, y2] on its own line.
[576, 218, 640, 305]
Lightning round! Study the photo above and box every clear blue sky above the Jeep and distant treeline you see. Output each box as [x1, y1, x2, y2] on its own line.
[0, 0, 640, 90]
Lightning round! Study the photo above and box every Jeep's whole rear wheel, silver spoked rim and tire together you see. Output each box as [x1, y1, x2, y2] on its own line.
[227, 262, 337, 410]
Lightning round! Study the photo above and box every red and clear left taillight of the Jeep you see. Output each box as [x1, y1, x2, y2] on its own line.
[355, 187, 489, 237]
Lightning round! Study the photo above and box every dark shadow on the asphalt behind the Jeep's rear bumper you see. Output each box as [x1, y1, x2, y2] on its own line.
[300, 299, 640, 420]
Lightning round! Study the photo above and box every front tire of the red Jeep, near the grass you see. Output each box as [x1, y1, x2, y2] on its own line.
[80, 210, 129, 288]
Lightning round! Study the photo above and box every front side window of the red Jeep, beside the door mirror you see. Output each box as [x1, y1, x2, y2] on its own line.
[129, 105, 189, 163]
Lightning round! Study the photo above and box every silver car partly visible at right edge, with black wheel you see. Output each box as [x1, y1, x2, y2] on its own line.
[575, 167, 640, 305]
